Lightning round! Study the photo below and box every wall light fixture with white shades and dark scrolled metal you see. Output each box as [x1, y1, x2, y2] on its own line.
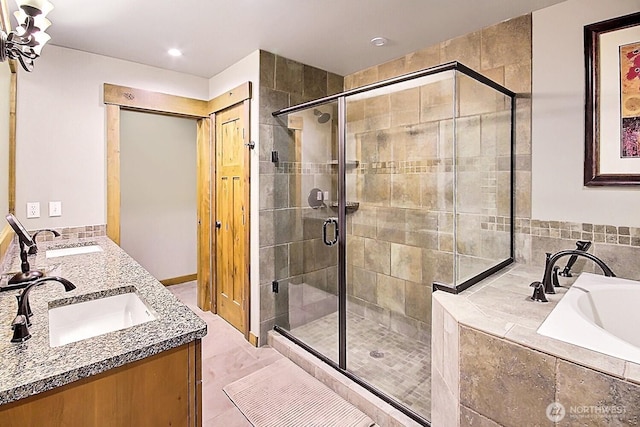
[0, 0, 53, 71]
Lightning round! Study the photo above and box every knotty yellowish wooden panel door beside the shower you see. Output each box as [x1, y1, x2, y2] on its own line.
[215, 104, 249, 335]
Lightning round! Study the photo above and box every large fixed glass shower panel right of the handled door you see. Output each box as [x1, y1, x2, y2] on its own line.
[346, 71, 454, 418]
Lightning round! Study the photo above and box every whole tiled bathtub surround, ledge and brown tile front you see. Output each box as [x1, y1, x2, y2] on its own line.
[432, 265, 640, 427]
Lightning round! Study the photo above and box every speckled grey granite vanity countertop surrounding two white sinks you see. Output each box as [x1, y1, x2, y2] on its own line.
[0, 237, 207, 405]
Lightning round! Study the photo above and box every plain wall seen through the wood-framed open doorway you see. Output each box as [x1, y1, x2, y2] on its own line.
[120, 111, 198, 280]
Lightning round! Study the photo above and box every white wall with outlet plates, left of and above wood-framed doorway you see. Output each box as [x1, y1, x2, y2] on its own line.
[16, 46, 208, 229]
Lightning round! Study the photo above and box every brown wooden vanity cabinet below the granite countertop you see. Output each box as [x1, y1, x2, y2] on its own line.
[0, 339, 202, 427]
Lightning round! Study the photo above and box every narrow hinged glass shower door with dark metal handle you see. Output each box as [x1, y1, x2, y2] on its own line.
[274, 102, 341, 363]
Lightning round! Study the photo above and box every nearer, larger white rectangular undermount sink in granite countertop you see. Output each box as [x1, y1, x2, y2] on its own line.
[49, 292, 155, 347]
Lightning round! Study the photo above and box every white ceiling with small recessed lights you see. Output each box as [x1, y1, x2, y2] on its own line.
[11, 0, 563, 78]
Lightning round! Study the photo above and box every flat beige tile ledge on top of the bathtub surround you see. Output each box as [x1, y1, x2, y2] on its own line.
[433, 264, 640, 383]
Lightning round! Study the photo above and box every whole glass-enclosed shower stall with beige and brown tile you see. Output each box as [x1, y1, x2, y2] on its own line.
[261, 58, 513, 426]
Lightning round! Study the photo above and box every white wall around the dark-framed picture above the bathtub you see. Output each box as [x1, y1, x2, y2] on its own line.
[532, 0, 640, 227]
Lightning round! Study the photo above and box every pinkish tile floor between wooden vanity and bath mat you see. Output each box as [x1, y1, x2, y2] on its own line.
[167, 282, 284, 427]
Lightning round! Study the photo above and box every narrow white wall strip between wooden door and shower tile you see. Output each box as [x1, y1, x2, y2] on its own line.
[209, 50, 260, 336]
